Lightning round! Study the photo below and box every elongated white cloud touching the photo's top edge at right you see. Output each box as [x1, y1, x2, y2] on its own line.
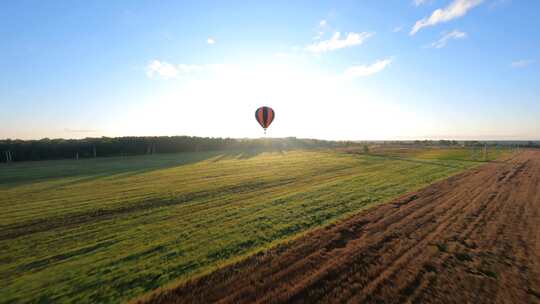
[409, 0, 483, 35]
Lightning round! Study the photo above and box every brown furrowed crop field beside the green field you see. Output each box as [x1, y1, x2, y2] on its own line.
[141, 151, 540, 303]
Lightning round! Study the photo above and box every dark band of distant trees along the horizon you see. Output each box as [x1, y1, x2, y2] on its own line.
[0, 136, 540, 162]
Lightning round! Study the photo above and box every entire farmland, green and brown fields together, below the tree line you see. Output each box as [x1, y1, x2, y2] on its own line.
[0, 140, 540, 303]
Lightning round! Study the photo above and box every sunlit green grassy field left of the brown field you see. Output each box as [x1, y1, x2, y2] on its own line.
[0, 149, 506, 303]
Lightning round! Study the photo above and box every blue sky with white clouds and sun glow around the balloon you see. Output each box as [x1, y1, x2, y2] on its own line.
[0, 0, 540, 140]
